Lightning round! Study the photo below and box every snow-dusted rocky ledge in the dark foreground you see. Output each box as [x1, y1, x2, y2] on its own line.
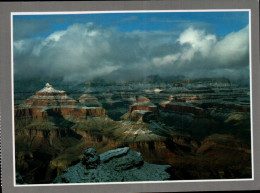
[53, 147, 171, 183]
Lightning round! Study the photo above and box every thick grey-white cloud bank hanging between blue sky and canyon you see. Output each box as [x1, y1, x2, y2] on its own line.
[13, 21, 249, 81]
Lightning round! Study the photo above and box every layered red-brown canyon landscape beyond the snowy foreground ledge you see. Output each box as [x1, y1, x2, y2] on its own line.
[14, 80, 252, 184]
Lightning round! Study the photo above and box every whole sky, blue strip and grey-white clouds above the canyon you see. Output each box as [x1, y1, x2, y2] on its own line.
[13, 11, 249, 83]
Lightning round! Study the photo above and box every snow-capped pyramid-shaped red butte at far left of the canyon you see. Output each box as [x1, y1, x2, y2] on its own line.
[15, 83, 106, 119]
